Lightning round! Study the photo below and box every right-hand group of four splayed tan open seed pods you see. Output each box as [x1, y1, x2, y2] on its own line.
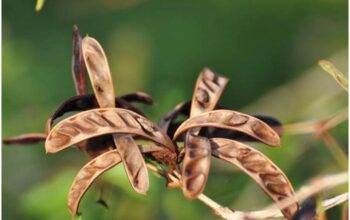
[160, 69, 298, 219]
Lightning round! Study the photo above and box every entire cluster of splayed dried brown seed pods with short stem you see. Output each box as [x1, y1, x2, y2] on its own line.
[4, 27, 298, 219]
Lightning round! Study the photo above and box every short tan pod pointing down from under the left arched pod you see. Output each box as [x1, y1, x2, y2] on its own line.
[113, 135, 149, 194]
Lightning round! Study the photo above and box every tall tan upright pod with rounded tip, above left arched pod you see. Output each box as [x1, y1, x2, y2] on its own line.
[82, 36, 114, 108]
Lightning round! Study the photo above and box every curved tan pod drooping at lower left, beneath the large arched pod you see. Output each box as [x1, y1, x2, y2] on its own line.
[68, 150, 121, 215]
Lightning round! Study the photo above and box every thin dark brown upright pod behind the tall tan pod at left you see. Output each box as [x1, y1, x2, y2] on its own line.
[72, 25, 87, 95]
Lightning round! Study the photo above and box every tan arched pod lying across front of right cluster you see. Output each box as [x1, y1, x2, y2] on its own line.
[173, 110, 280, 146]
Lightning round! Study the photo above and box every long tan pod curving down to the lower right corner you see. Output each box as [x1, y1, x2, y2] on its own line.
[210, 138, 298, 219]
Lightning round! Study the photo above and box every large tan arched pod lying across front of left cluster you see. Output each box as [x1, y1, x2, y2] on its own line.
[45, 108, 175, 153]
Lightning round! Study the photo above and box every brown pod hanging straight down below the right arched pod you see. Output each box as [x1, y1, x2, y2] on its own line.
[182, 132, 211, 199]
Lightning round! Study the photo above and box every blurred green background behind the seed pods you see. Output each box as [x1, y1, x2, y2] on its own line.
[2, 0, 348, 220]
